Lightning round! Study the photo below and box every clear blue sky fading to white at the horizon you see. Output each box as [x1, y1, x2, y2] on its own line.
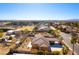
[0, 3, 79, 20]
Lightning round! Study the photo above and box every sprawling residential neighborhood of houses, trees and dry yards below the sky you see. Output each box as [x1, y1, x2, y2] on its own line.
[0, 21, 79, 55]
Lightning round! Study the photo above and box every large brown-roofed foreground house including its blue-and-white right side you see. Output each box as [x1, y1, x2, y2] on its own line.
[32, 33, 62, 51]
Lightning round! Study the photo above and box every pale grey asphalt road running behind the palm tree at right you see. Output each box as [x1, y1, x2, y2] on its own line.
[60, 32, 79, 55]
